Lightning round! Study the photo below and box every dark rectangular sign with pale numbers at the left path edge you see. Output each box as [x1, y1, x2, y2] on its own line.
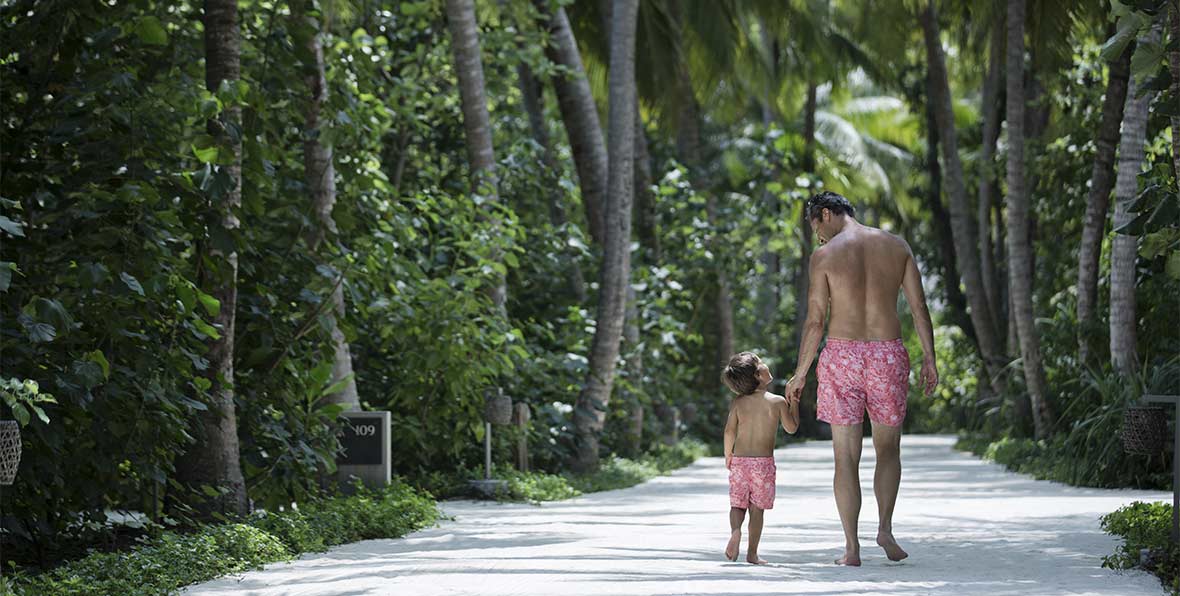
[336, 412, 393, 489]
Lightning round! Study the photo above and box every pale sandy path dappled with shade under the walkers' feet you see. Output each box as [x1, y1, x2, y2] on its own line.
[186, 435, 1171, 596]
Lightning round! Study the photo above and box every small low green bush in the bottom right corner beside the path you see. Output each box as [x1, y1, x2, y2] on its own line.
[1102, 500, 1180, 594]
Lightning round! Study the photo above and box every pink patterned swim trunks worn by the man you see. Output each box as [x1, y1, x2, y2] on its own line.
[815, 338, 910, 426]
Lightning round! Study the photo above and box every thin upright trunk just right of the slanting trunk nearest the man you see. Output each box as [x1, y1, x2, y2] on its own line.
[976, 19, 1004, 330]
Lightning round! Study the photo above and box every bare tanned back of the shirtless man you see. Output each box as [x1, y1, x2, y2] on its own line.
[812, 220, 912, 340]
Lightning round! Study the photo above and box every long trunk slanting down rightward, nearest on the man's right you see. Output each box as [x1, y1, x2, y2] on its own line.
[922, 2, 1011, 394]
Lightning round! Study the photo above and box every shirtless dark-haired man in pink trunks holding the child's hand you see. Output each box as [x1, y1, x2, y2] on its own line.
[785, 191, 938, 565]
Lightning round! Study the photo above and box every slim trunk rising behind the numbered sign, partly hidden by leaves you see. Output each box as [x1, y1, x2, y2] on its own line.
[303, 11, 361, 411]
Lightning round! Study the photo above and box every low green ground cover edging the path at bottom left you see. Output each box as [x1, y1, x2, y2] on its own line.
[12, 482, 439, 596]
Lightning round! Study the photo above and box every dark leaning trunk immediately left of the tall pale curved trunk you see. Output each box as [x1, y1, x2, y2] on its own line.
[535, 0, 608, 245]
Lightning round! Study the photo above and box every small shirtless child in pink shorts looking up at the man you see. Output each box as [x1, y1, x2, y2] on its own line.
[721, 352, 799, 565]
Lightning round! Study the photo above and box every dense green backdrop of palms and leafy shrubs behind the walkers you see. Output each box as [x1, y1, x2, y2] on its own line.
[0, 0, 1180, 581]
